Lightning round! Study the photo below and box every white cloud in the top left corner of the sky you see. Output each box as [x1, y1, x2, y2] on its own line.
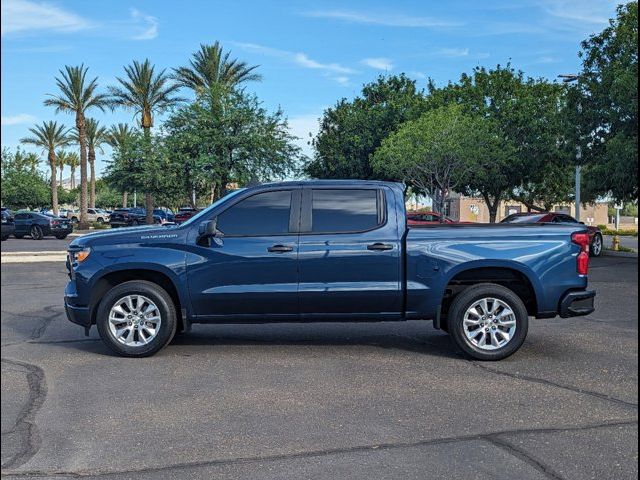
[1, 0, 95, 36]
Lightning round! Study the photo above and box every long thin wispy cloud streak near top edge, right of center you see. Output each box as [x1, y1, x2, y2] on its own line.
[303, 10, 461, 28]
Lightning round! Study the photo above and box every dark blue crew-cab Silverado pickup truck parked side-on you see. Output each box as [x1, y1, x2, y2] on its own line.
[65, 180, 595, 360]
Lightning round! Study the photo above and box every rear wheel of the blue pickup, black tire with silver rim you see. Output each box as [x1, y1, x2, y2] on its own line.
[447, 283, 529, 360]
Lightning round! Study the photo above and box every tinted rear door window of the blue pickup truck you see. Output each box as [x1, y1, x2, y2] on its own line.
[311, 189, 384, 233]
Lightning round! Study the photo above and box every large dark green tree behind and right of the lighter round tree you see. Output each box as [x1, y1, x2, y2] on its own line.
[427, 65, 572, 216]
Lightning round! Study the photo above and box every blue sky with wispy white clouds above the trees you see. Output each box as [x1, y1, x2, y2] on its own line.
[0, 0, 616, 178]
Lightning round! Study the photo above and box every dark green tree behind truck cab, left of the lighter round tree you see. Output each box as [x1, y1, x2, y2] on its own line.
[305, 74, 426, 179]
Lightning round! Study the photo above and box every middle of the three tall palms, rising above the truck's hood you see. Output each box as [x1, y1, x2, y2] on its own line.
[109, 59, 182, 224]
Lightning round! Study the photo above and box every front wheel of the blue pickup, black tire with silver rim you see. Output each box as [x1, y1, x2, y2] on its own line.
[96, 280, 178, 357]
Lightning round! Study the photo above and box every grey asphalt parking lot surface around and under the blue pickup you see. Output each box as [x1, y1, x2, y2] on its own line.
[2, 239, 638, 479]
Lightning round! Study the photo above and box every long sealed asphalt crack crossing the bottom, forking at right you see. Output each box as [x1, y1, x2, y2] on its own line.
[3, 419, 638, 480]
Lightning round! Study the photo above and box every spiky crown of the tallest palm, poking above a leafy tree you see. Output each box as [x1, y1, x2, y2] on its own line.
[173, 42, 262, 95]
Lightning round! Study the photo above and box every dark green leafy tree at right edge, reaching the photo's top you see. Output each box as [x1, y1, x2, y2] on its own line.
[572, 2, 638, 201]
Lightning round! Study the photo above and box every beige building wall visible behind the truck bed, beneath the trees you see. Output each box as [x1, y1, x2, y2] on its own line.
[449, 196, 608, 225]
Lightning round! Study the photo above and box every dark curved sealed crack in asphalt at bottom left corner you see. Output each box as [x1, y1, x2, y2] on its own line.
[1, 358, 47, 469]
